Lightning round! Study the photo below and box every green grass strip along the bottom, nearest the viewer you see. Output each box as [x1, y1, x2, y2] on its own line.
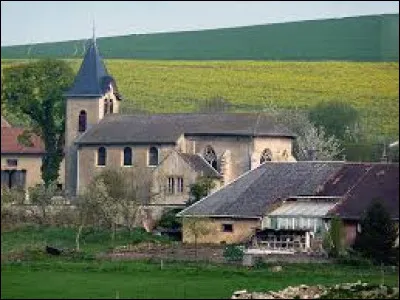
[1, 259, 397, 299]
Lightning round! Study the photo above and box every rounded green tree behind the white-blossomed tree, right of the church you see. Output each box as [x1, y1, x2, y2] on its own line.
[308, 101, 359, 142]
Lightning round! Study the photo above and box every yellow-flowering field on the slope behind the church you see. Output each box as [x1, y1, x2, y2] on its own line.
[2, 60, 399, 137]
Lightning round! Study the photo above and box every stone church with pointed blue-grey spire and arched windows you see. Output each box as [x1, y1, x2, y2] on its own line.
[65, 38, 295, 206]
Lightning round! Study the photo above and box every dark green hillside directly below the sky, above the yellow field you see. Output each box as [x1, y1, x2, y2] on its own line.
[1, 14, 399, 61]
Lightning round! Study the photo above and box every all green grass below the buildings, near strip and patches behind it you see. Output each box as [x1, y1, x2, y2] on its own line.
[1, 227, 398, 299]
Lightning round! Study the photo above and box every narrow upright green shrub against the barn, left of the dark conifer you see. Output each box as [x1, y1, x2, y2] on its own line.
[324, 216, 344, 257]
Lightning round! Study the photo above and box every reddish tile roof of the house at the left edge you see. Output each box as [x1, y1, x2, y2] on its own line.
[1, 127, 45, 154]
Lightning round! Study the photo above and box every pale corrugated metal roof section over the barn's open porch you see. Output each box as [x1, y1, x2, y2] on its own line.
[268, 201, 337, 217]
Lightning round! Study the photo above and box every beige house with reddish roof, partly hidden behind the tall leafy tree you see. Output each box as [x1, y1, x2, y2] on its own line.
[1, 116, 64, 191]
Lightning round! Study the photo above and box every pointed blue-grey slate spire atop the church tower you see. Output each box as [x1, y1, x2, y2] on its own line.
[66, 28, 112, 97]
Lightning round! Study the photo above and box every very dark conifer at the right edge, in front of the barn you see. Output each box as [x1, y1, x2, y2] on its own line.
[354, 199, 397, 263]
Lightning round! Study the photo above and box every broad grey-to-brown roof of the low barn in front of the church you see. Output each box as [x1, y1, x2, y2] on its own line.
[178, 161, 399, 220]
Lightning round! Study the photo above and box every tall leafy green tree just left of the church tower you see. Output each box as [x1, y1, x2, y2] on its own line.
[1, 59, 74, 187]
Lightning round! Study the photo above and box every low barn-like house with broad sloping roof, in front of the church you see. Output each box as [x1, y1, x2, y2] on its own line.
[177, 161, 399, 251]
